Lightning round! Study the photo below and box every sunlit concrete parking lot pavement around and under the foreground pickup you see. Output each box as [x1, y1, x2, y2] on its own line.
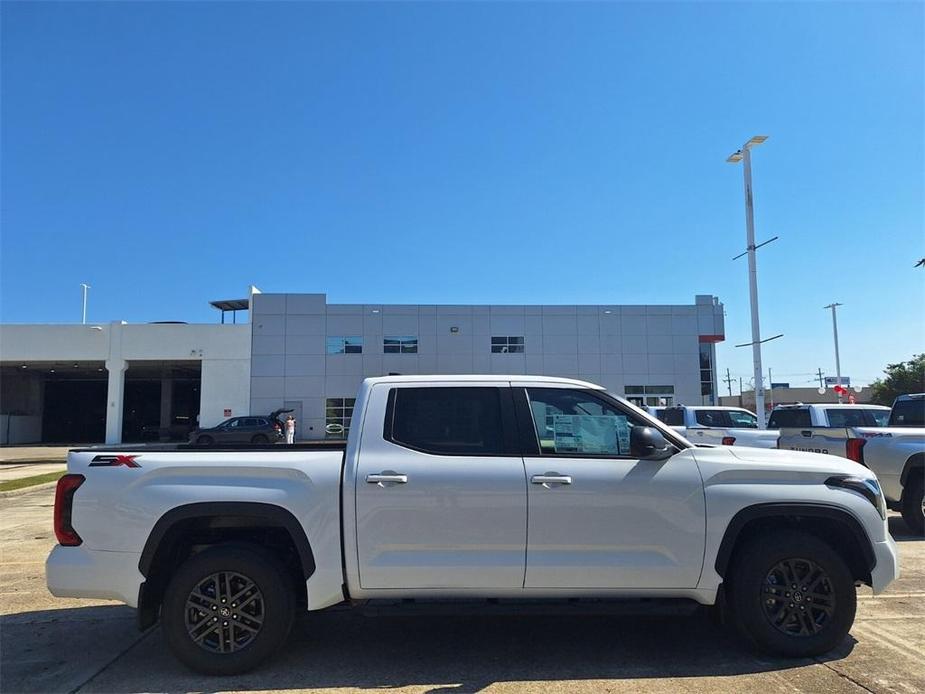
[0, 488, 925, 694]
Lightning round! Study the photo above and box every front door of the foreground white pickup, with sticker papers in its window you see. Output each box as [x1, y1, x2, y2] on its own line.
[514, 387, 706, 588]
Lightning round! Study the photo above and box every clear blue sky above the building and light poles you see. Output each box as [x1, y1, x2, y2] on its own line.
[0, 2, 925, 390]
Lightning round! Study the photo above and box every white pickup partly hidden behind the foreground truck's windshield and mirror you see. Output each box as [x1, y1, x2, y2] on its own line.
[646, 405, 777, 448]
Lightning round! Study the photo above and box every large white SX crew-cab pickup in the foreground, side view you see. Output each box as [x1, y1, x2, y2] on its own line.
[46, 376, 898, 674]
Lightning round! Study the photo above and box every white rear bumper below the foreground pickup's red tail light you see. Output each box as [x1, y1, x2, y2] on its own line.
[45, 545, 145, 607]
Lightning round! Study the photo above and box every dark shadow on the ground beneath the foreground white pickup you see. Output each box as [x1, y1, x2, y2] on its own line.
[57, 610, 855, 694]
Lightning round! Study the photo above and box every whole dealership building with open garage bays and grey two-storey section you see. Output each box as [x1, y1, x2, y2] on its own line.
[0, 288, 724, 444]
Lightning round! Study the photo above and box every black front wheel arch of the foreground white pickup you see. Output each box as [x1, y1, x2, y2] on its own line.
[715, 503, 876, 585]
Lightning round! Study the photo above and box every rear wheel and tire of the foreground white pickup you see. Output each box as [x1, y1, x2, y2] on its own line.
[161, 544, 295, 675]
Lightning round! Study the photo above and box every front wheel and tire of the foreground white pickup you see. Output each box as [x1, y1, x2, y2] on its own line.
[729, 530, 857, 657]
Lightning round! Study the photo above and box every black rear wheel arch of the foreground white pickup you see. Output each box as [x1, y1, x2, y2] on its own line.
[138, 502, 315, 629]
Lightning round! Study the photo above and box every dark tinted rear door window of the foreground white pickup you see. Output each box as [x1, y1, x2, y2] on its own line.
[385, 387, 505, 456]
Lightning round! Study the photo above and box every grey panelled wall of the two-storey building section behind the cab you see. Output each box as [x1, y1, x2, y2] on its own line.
[251, 294, 724, 438]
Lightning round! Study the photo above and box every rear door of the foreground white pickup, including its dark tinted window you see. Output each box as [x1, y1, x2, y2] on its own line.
[355, 382, 527, 589]
